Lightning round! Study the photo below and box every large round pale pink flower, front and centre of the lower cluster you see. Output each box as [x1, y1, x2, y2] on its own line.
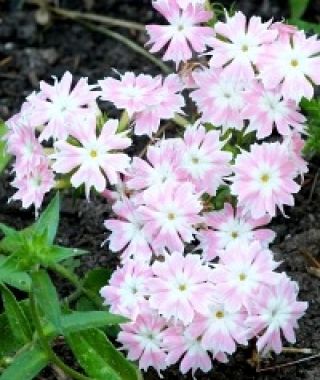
[149, 252, 213, 325]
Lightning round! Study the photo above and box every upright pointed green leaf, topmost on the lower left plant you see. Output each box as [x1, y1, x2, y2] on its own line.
[24, 193, 60, 245]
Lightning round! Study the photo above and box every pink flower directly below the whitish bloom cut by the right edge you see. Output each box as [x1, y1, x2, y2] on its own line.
[242, 83, 306, 139]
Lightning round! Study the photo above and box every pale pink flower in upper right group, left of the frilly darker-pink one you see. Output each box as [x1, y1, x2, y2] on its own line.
[191, 68, 245, 132]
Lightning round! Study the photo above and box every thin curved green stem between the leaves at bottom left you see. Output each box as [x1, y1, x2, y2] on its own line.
[30, 292, 92, 380]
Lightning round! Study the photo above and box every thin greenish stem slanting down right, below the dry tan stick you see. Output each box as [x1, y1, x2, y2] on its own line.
[76, 20, 172, 74]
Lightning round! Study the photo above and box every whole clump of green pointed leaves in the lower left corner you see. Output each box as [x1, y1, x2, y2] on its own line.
[0, 194, 141, 380]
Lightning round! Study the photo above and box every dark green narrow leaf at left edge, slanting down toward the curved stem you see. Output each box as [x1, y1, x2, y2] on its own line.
[0, 284, 32, 344]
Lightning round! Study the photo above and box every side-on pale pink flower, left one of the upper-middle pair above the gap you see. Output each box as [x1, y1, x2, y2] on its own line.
[98, 72, 162, 117]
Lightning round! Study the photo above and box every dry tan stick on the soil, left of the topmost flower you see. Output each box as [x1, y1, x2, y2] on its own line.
[49, 7, 145, 31]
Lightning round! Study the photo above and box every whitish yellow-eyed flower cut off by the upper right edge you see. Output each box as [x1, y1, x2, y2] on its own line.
[258, 31, 320, 103]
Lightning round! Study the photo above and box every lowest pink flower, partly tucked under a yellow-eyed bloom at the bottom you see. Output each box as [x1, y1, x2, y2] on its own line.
[163, 325, 212, 376]
